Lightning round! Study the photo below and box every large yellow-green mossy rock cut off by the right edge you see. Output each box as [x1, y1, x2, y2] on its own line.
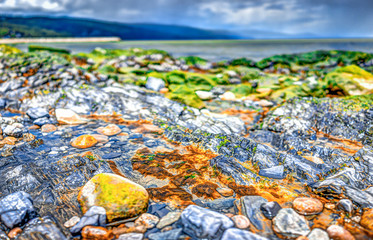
[324, 65, 373, 96]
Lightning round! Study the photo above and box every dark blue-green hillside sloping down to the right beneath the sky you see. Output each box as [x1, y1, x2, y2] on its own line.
[0, 16, 240, 40]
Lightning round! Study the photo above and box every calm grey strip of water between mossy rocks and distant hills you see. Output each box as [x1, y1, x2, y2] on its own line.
[11, 39, 373, 61]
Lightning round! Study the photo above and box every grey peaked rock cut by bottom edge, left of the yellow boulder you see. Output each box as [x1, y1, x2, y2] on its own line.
[17, 217, 70, 240]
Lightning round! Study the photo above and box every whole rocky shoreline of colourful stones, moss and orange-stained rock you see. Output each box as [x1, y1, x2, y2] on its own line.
[0, 45, 373, 240]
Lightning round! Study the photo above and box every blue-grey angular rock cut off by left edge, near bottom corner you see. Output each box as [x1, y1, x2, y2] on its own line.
[0, 191, 37, 229]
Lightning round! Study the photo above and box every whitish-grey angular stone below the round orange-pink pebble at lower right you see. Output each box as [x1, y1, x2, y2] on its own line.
[273, 208, 310, 239]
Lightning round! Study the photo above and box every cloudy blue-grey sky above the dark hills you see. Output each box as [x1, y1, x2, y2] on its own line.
[0, 0, 373, 37]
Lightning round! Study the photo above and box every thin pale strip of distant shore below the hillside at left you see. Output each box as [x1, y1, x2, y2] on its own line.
[0, 37, 121, 44]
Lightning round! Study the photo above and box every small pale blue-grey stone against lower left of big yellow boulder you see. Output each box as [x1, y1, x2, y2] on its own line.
[69, 206, 106, 234]
